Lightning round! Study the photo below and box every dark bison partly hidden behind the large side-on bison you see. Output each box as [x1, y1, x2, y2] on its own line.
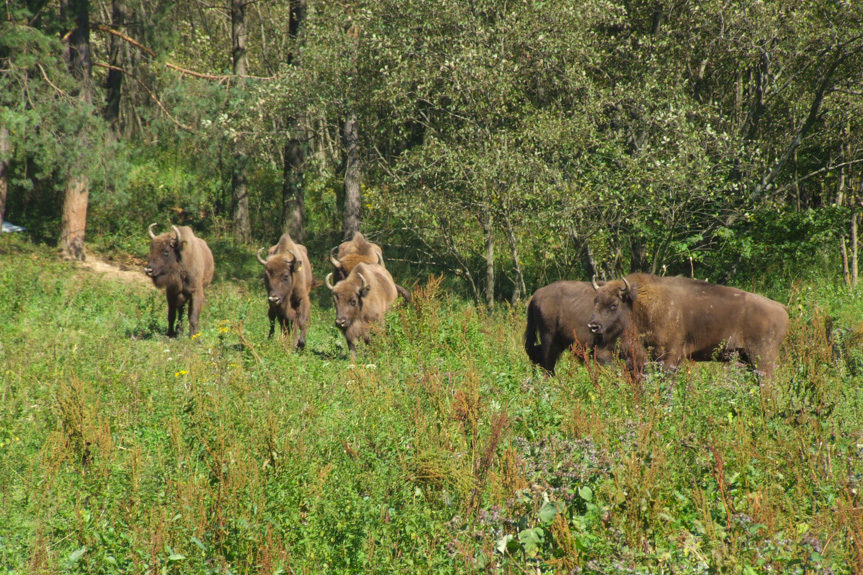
[524, 281, 612, 375]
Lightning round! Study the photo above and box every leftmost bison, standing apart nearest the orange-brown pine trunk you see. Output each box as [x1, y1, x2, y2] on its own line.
[144, 224, 215, 337]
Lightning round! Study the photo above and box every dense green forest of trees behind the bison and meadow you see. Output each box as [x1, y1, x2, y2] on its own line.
[0, 0, 863, 296]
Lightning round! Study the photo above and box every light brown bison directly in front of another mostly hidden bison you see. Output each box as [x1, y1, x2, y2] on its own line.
[324, 263, 398, 354]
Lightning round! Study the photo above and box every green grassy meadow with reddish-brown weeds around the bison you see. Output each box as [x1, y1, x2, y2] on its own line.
[0, 234, 863, 575]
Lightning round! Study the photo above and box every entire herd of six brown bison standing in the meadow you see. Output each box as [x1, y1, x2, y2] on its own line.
[144, 224, 788, 377]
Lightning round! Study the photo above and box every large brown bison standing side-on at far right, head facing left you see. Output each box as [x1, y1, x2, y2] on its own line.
[590, 274, 788, 378]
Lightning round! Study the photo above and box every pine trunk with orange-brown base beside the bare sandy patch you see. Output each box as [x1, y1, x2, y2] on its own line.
[59, 0, 93, 260]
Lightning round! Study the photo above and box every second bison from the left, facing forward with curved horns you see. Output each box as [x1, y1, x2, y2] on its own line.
[257, 234, 312, 349]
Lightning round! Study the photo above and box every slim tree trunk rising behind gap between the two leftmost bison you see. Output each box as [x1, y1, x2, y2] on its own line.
[231, 0, 252, 243]
